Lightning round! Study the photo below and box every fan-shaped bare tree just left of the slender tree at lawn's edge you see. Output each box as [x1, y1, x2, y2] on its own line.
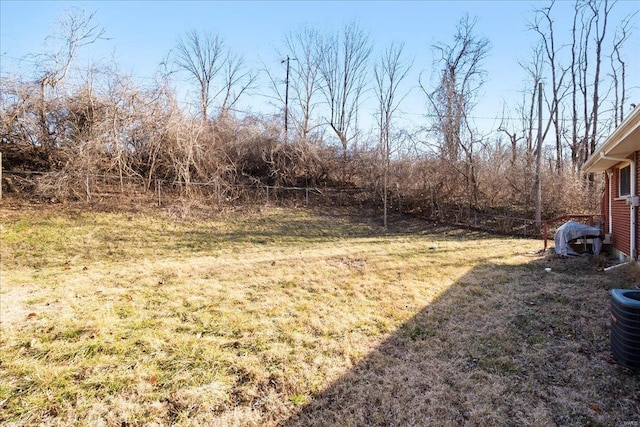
[318, 23, 371, 164]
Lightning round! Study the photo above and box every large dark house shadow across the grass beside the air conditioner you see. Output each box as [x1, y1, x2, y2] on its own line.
[280, 259, 640, 427]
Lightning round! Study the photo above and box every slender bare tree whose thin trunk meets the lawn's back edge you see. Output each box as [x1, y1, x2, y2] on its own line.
[374, 43, 411, 227]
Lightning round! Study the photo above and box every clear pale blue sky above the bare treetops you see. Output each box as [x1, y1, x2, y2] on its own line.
[0, 0, 640, 136]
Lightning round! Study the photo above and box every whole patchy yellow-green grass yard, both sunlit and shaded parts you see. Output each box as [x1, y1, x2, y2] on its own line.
[0, 202, 640, 426]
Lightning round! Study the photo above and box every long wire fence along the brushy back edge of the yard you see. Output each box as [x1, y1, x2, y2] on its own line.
[2, 171, 543, 238]
